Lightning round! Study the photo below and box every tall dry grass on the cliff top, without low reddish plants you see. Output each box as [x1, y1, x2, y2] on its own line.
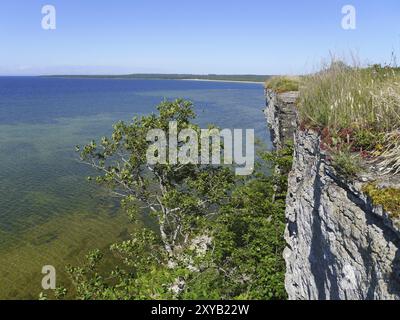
[299, 61, 400, 173]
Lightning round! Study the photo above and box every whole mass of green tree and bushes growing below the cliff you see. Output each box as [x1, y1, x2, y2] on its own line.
[55, 100, 292, 299]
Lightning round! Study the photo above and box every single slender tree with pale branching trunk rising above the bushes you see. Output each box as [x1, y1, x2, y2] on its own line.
[78, 99, 235, 262]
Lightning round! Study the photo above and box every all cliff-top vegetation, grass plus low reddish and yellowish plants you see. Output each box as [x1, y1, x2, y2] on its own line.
[298, 61, 400, 217]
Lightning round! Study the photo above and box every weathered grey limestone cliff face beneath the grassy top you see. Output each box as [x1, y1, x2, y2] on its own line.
[265, 90, 400, 300]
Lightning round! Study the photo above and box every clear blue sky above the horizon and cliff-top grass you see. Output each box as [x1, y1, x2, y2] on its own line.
[0, 0, 400, 75]
